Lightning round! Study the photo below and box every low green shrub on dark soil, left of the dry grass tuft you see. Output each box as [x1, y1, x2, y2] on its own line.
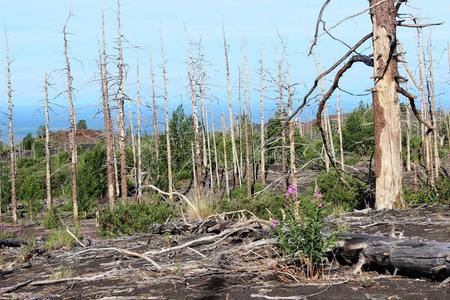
[98, 203, 172, 237]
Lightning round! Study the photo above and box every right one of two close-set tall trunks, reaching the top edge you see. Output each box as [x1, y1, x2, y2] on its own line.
[117, 0, 128, 203]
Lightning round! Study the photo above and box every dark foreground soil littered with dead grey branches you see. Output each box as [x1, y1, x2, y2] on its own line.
[0, 206, 450, 300]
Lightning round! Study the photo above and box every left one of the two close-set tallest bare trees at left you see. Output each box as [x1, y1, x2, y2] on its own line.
[99, 11, 116, 211]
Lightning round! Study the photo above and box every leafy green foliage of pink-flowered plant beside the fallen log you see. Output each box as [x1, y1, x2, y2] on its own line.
[275, 197, 339, 277]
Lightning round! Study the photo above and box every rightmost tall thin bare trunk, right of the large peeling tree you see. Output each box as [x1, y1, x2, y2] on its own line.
[428, 33, 441, 182]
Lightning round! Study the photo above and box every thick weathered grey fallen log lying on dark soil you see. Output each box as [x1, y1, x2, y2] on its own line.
[336, 233, 450, 280]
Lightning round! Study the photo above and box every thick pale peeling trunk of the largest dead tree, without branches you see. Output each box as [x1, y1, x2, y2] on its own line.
[370, 0, 404, 209]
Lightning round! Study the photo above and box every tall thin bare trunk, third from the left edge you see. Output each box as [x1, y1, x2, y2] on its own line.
[63, 14, 78, 223]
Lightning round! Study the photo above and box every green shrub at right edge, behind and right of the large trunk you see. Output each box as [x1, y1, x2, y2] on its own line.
[404, 177, 450, 205]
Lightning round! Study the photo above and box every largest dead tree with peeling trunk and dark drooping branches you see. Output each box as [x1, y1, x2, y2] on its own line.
[290, 0, 437, 209]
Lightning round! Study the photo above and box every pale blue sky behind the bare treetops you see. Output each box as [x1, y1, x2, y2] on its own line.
[0, 0, 450, 137]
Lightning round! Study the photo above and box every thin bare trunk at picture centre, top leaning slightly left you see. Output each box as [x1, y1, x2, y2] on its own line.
[222, 27, 241, 188]
